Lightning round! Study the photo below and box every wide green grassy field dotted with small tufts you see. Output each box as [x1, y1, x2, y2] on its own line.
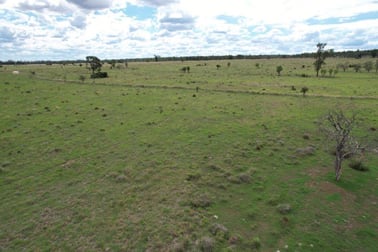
[0, 59, 378, 251]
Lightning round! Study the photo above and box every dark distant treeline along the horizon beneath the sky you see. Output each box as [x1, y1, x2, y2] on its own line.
[0, 49, 378, 65]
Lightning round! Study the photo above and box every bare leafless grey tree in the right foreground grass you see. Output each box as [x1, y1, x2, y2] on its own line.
[320, 110, 361, 181]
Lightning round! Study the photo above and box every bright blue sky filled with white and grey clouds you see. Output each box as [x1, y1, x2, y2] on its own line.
[0, 0, 378, 61]
